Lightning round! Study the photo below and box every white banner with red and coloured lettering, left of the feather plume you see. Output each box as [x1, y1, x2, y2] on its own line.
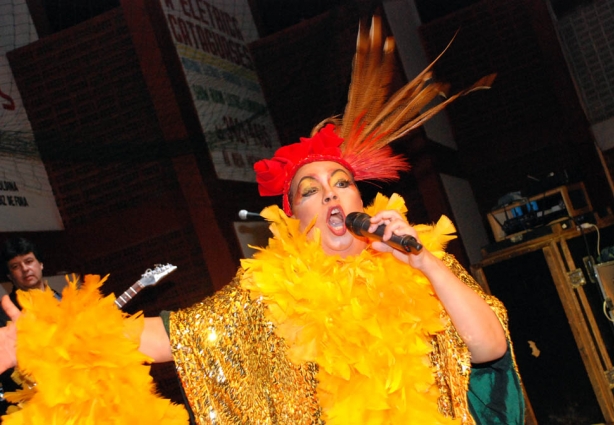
[161, 0, 279, 182]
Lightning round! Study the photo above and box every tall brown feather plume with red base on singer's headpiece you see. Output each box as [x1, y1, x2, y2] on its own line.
[337, 16, 496, 180]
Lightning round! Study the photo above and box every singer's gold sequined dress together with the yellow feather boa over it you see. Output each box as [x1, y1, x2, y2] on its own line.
[169, 195, 524, 425]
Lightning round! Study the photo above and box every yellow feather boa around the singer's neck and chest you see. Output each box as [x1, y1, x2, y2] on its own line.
[242, 195, 455, 425]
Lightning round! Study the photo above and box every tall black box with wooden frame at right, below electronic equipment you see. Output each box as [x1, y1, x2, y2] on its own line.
[472, 220, 614, 424]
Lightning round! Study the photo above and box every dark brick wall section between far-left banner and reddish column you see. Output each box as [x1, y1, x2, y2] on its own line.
[9, 8, 212, 308]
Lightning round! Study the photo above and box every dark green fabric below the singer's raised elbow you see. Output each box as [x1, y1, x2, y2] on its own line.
[467, 347, 525, 425]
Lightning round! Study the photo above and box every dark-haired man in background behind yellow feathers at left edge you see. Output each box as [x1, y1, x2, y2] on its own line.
[0, 238, 60, 415]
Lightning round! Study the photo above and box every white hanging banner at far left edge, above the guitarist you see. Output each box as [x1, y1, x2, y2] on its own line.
[0, 0, 64, 232]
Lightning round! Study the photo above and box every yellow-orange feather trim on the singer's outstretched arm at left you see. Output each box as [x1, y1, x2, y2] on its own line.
[2, 275, 188, 425]
